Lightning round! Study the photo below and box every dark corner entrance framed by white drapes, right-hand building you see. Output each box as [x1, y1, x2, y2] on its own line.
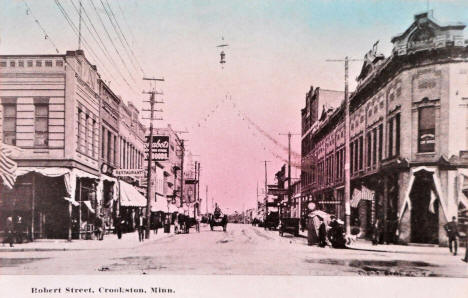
[410, 171, 439, 244]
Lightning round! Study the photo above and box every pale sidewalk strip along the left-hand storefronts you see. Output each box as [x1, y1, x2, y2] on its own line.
[0, 229, 174, 253]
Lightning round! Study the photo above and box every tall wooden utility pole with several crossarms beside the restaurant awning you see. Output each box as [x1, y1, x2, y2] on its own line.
[143, 78, 164, 239]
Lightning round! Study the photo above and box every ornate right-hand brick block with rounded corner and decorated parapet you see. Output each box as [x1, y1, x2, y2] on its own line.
[302, 12, 468, 245]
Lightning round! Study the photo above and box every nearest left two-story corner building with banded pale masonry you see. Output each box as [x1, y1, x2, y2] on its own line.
[0, 51, 100, 239]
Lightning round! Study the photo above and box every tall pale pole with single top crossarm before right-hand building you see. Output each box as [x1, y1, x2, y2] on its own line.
[327, 56, 362, 236]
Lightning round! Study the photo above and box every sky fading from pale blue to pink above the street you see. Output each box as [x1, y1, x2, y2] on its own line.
[0, 0, 468, 211]
